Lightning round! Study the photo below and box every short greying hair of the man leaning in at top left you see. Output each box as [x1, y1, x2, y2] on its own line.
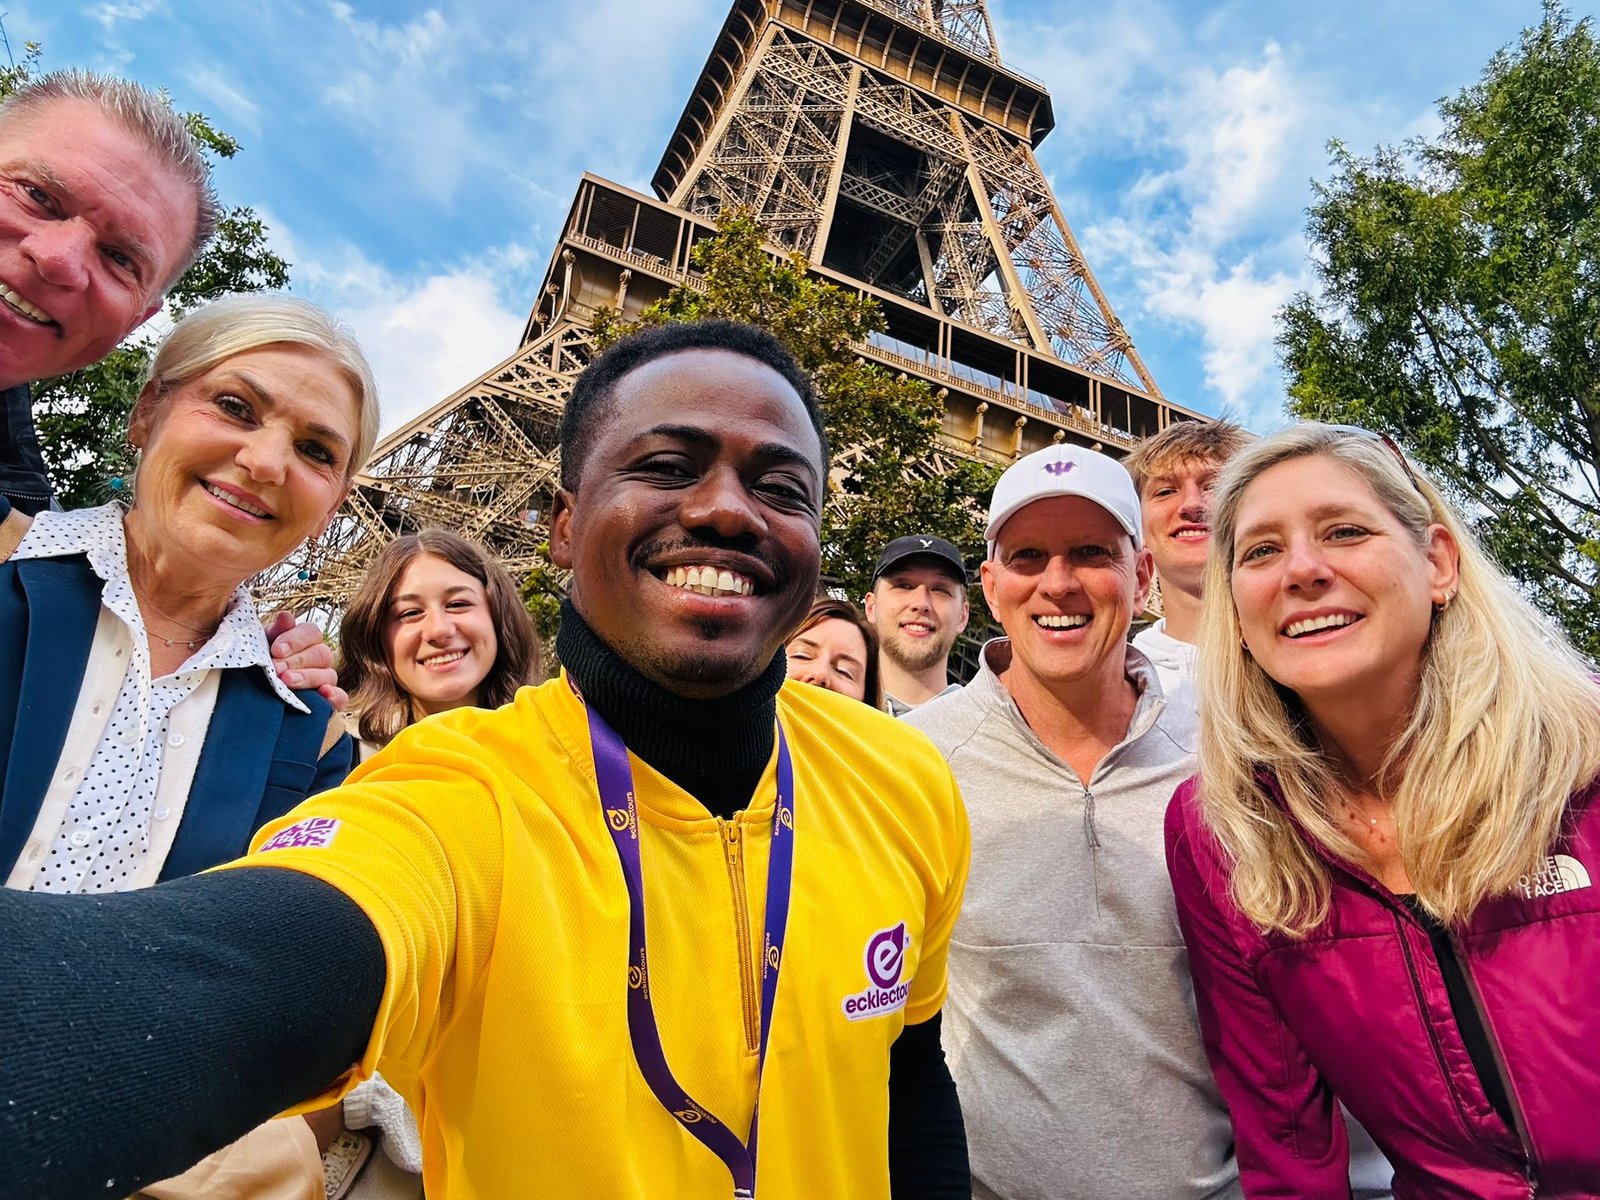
[0, 69, 222, 294]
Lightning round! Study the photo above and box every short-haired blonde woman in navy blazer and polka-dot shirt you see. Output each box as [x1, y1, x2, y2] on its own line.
[0, 294, 378, 891]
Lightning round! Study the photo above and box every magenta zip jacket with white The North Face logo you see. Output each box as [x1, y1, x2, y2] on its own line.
[1166, 779, 1600, 1200]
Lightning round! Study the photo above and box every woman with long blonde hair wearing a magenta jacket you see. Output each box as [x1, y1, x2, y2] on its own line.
[1166, 424, 1600, 1200]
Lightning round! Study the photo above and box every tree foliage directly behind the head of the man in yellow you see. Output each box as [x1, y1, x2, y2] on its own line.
[595, 213, 998, 608]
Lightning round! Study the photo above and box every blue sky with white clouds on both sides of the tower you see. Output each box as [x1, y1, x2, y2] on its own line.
[15, 0, 1590, 429]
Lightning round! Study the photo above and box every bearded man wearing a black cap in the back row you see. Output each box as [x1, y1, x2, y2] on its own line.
[866, 533, 968, 717]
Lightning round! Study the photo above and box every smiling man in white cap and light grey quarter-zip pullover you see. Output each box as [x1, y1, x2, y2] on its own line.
[904, 445, 1240, 1200]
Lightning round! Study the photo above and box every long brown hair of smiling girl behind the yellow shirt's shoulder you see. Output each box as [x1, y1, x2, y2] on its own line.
[338, 530, 544, 742]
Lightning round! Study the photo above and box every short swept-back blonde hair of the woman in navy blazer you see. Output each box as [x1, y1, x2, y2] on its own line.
[139, 291, 379, 480]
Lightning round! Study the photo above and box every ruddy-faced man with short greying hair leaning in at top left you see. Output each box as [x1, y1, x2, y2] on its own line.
[0, 70, 219, 514]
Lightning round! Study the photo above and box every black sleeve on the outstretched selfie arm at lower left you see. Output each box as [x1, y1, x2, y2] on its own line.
[0, 867, 386, 1200]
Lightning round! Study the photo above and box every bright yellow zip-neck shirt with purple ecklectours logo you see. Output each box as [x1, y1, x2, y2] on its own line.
[234, 677, 970, 1200]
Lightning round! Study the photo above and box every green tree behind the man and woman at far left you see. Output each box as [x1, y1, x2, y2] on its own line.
[0, 42, 290, 509]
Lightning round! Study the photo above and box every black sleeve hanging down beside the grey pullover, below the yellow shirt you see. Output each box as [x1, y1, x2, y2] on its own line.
[890, 1013, 973, 1200]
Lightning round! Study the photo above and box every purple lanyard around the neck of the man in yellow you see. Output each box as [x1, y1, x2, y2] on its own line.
[574, 688, 795, 1200]
